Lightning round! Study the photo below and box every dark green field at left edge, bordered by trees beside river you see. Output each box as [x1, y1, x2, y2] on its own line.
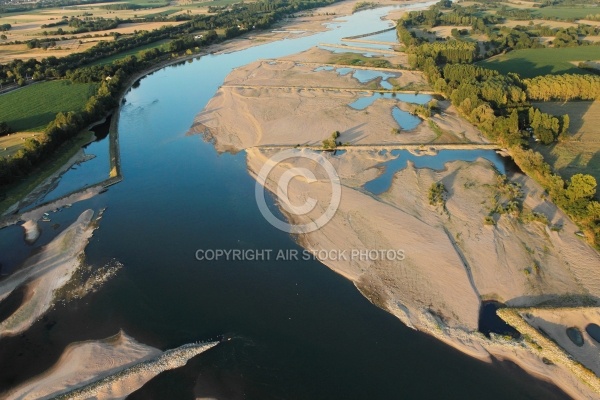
[0, 80, 96, 132]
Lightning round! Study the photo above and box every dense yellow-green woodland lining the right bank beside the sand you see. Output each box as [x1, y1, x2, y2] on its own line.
[397, 1, 600, 246]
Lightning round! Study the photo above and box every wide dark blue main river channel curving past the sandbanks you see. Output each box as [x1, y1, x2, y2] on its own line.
[0, 3, 562, 399]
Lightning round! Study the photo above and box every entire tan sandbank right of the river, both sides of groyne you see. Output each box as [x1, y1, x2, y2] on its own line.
[190, 21, 600, 398]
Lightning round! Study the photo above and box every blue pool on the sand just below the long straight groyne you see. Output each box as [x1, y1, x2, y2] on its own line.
[364, 150, 508, 195]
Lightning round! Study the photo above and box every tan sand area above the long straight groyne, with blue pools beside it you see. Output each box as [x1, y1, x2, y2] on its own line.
[190, 61, 483, 151]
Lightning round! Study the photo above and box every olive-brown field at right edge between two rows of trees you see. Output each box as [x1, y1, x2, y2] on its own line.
[534, 101, 600, 186]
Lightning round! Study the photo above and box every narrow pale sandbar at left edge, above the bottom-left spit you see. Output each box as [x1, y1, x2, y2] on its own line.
[0, 210, 95, 337]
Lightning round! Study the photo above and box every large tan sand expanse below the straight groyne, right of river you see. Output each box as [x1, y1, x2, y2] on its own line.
[247, 148, 600, 398]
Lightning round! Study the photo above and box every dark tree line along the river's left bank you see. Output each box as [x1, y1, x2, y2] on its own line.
[0, 0, 342, 186]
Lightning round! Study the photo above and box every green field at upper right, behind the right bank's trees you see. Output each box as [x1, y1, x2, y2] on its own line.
[478, 46, 600, 78]
